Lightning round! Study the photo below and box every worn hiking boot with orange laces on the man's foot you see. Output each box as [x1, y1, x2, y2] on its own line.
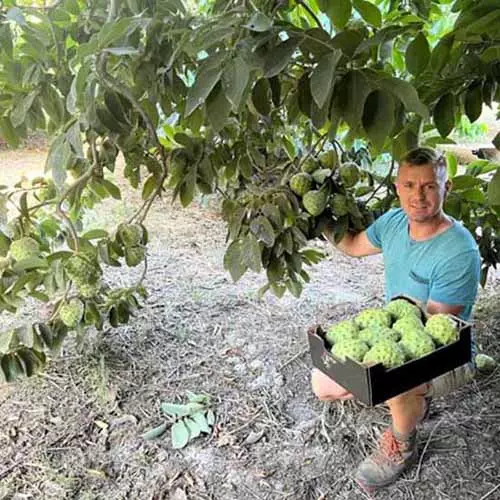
[355, 428, 418, 493]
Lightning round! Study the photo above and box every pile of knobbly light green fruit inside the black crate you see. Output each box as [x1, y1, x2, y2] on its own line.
[325, 299, 459, 369]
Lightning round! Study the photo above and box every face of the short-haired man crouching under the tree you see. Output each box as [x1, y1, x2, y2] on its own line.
[396, 163, 450, 222]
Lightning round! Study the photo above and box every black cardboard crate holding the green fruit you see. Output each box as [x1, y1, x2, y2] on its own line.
[308, 297, 472, 406]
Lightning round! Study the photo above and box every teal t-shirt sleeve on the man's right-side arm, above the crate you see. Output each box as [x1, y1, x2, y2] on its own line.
[429, 250, 481, 306]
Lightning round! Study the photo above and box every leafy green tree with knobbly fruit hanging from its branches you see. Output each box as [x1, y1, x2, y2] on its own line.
[0, 0, 500, 381]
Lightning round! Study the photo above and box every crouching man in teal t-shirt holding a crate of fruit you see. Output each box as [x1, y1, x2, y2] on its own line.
[312, 148, 480, 492]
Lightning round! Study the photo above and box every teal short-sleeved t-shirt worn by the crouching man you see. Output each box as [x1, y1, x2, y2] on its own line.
[366, 208, 481, 320]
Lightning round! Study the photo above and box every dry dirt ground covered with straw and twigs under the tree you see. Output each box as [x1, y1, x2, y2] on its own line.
[0, 152, 500, 500]
